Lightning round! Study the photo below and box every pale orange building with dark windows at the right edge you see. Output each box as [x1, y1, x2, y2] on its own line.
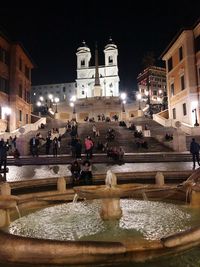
[162, 22, 200, 127]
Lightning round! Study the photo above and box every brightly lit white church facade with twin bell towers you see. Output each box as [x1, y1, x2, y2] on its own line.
[76, 39, 119, 99]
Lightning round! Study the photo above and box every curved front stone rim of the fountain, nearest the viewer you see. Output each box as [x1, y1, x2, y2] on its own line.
[0, 227, 200, 266]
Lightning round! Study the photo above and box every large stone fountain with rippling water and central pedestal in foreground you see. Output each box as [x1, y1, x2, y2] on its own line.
[0, 169, 200, 266]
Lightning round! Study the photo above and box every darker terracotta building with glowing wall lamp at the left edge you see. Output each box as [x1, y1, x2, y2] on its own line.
[0, 32, 33, 132]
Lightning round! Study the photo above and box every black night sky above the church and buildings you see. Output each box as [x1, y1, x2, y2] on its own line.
[0, 0, 200, 90]
